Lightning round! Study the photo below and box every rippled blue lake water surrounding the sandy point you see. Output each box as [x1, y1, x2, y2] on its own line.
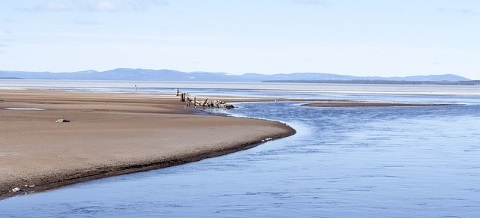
[0, 82, 480, 217]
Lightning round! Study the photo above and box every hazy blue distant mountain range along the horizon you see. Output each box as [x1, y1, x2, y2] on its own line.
[0, 68, 471, 83]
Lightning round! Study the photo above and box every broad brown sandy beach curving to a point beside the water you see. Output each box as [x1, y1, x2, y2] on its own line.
[0, 90, 295, 199]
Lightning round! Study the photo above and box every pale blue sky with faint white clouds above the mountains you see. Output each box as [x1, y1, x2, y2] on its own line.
[0, 0, 480, 79]
